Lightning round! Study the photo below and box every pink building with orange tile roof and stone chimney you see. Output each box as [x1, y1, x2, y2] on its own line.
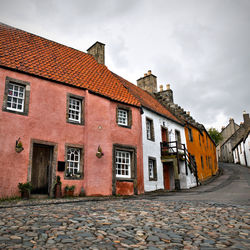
[0, 24, 144, 197]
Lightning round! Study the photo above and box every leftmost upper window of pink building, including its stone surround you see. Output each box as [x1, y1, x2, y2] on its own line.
[3, 77, 30, 115]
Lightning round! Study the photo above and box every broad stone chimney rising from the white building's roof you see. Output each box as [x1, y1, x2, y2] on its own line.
[137, 70, 157, 94]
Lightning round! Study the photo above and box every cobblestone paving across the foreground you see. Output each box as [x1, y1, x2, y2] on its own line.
[0, 199, 250, 249]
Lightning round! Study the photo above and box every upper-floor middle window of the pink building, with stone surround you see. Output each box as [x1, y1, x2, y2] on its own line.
[66, 94, 84, 125]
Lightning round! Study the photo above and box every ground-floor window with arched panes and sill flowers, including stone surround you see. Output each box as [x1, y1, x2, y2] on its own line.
[65, 145, 83, 179]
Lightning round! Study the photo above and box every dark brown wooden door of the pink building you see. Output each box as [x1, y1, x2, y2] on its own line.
[31, 144, 52, 194]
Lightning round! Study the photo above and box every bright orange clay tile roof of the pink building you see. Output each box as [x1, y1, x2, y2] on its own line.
[0, 23, 140, 106]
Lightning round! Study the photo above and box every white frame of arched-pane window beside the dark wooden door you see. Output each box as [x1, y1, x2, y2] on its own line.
[66, 147, 81, 176]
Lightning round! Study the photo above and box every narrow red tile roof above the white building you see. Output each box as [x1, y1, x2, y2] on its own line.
[113, 73, 183, 124]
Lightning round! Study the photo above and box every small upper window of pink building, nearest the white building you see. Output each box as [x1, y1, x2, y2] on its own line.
[116, 105, 132, 128]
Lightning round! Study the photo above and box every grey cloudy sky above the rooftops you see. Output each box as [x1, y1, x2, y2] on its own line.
[0, 0, 250, 129]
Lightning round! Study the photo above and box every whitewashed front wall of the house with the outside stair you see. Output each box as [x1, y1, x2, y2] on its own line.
[142, 108, 196, 192]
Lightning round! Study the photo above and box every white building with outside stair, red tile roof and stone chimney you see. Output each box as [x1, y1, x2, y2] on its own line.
[114, 71, 197, 192]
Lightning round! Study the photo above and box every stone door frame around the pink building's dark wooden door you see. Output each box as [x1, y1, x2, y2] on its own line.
[28, 139, 58, 197]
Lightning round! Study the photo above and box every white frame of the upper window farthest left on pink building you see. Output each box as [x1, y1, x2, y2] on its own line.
[6, 82, 25, 112]
